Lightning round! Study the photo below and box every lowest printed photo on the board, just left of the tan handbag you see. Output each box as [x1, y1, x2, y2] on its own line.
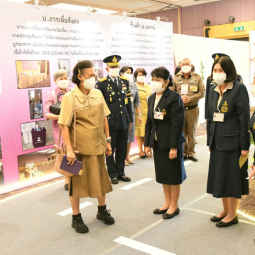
[18, 148, 56, 182]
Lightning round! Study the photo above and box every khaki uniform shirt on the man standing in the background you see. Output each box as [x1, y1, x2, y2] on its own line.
[171, 71, 205, 106]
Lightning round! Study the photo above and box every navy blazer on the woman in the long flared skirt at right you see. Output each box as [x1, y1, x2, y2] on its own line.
[207, 81, 250, 151]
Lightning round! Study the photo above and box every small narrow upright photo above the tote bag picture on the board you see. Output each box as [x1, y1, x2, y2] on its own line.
[28, 89, 43, 120]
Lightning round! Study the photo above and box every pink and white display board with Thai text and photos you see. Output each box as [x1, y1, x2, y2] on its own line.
[0, 1, 174, 193]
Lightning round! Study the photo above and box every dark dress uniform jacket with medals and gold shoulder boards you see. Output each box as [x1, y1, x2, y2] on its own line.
[96, 76, 133, 130]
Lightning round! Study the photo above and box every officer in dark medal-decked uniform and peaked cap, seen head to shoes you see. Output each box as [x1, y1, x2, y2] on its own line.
[96, 55, 133, 184]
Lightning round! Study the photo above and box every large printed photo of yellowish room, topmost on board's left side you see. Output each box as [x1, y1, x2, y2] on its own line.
[16, 60, 51, 89]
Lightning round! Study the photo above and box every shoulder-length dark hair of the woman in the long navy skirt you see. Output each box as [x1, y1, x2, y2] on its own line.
[211, 57, 237, 82]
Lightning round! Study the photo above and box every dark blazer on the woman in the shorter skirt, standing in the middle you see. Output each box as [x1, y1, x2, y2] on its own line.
[144, 88, 185, 150]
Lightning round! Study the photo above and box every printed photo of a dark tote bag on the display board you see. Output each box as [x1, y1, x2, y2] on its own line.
[21, 120, 54, 151]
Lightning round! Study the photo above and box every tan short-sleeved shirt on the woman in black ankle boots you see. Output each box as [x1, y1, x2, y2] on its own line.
[58, 86, 110, 155]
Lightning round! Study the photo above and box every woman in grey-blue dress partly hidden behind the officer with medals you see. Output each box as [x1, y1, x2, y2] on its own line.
[120, 66, 142, 166]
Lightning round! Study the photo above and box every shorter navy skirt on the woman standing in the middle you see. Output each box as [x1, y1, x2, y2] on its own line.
[153, 141, 187, 185]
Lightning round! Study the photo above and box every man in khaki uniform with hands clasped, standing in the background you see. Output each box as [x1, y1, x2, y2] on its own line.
[171, 58, 205, 162]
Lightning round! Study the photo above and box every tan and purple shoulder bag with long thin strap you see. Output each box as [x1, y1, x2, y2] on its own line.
[54, 95, 83, 176]
